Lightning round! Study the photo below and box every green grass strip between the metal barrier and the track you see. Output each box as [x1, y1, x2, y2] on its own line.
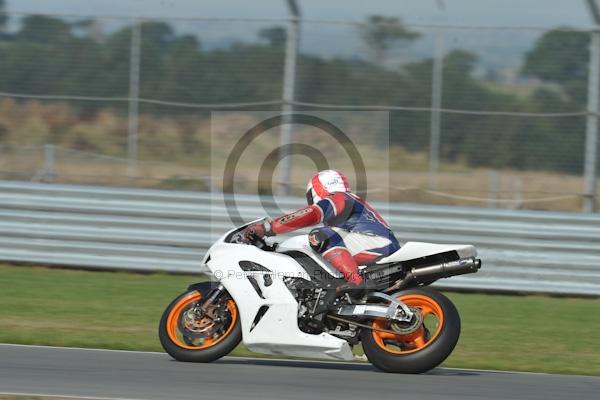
[0, 266, 600, 375]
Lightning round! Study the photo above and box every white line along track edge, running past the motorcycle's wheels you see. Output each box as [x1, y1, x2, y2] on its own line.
[0, 343, 568, 376]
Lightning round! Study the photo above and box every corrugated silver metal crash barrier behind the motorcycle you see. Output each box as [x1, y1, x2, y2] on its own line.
[0, 181, 600, 295]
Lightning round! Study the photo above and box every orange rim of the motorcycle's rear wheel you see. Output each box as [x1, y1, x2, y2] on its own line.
[372, 294, 444, 355]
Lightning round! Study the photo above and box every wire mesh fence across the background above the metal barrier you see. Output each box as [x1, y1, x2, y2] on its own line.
[0, 14, 597, 211]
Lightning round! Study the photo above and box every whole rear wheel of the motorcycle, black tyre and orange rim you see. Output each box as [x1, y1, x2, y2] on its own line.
[361, 288, 460, 374]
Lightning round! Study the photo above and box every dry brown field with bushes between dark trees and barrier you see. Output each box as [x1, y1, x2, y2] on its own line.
[0, 97, 600, 211]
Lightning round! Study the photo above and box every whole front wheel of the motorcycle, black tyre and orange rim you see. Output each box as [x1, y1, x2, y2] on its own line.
[158, 282, 242, 362]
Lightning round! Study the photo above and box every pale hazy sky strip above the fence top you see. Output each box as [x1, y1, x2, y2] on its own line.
[7, 0, 590, 27]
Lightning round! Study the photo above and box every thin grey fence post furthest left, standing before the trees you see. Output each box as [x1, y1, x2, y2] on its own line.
[127, 20, 142, 178]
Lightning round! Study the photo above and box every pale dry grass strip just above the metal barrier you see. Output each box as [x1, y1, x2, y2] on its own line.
[0, 149, 600, 212]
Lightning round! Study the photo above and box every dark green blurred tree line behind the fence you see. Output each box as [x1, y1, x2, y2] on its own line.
[0, 11, 589, 173]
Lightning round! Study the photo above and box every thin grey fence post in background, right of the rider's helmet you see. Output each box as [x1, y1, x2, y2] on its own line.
[429, 31, 444, 189]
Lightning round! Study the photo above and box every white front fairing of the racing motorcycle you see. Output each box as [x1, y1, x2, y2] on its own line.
[204, 227, 354, 360]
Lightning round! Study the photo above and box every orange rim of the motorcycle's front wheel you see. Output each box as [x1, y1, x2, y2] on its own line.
[167, 292, 237, 350]
